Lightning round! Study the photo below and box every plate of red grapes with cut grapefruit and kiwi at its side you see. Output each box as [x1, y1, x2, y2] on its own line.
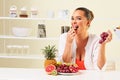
[45, 63, 79, 76]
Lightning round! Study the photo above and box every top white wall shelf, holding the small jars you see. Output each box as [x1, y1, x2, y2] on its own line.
[0, 17, 69, 21]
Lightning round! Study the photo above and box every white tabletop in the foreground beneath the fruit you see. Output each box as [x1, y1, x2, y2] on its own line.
[0, 68, 120, 80]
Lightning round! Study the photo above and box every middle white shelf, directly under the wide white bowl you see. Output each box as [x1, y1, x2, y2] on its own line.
[0, 35, 59, 40]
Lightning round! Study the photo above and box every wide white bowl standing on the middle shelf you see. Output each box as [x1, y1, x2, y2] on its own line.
[12, 27, 32, 37]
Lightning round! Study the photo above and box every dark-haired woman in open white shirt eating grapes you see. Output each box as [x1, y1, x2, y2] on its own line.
[58, 7, 112, 70]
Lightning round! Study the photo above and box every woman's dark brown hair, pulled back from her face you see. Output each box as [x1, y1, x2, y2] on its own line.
[76, 7, 94, 21]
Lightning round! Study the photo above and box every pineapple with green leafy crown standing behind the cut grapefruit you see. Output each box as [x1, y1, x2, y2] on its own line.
[42, 45, 57, 67]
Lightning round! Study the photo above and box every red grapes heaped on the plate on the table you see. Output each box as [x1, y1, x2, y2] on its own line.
[57, 64, 78, 73]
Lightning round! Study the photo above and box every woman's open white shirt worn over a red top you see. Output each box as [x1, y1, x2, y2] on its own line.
[58, 33, 100, 70]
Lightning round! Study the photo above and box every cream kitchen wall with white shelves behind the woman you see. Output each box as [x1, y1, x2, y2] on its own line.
[0, 0, 120, 70]
